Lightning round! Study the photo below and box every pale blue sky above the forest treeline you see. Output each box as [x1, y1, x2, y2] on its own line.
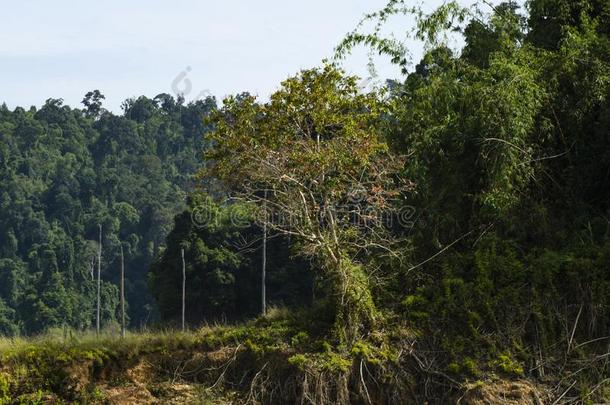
[0, 0, 480, 112]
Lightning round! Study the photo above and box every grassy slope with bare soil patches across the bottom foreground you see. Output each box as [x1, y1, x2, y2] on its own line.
[0, 311, 542, 404]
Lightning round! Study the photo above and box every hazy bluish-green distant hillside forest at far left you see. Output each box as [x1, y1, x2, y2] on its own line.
[0, 91, 216, 334]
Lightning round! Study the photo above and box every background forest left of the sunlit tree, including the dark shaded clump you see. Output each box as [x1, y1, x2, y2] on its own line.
[0, 91, 311, 335]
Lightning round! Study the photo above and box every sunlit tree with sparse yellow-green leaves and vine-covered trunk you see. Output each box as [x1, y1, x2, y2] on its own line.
[203, 65, 411, 341]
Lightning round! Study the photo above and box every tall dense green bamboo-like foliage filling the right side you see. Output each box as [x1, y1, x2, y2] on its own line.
[332, 0, 610, 395]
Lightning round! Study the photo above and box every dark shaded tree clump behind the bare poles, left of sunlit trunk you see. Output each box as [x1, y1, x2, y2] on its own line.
[149, 192, 312, 324]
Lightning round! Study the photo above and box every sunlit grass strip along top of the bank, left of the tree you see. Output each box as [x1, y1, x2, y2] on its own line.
[0, 309, 302, 396]
